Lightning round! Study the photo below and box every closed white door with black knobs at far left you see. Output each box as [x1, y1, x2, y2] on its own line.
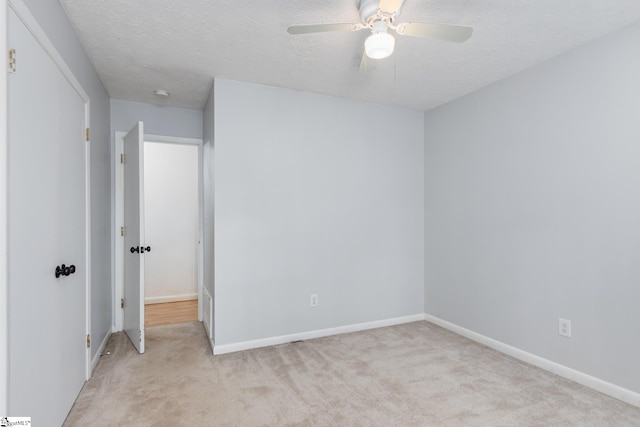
[8, 5, 88, 425]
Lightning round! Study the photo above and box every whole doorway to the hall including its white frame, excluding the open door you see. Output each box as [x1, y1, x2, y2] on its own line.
[114, 132, 204, 342]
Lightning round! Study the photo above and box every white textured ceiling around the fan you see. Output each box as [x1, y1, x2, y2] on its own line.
[60, 0, 640, 110]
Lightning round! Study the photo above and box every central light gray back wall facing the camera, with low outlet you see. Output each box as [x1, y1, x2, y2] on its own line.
[214, 80, 424, 345]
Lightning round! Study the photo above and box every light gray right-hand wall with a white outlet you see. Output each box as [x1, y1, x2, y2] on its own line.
[425, 21, 640, 392]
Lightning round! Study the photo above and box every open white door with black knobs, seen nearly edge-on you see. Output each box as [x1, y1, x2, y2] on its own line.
[123, 122, 148, 353]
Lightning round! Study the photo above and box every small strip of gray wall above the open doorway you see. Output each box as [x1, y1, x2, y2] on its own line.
[111, 99, 202, 139]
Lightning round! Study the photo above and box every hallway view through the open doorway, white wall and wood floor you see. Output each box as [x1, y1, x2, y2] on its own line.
[144, 139, 199, 328]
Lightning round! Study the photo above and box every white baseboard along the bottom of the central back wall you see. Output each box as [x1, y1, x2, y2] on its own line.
[212, 314, 424, 355]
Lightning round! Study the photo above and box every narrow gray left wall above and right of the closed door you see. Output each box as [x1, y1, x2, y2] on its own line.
[24, 0, 112, 357]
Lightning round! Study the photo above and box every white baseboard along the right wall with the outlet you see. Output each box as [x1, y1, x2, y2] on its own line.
[424, 314, 640, 407]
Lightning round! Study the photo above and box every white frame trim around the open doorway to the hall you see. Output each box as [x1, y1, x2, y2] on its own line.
[112, 131, 204, 332]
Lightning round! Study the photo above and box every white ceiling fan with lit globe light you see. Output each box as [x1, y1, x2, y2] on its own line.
[287, 0, 473, 70]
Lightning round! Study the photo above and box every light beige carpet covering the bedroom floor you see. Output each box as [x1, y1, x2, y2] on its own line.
[65, 322, 640, 427]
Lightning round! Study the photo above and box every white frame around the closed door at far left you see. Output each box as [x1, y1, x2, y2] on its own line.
[0, 0, 92, 390]
